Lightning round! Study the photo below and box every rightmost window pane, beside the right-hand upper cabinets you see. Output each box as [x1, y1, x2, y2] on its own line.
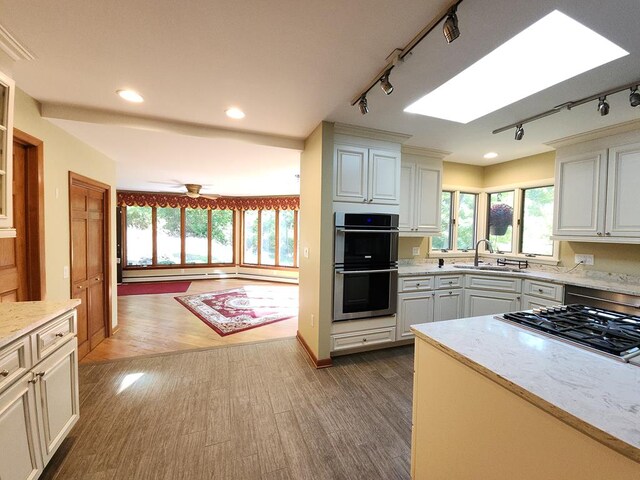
[520, 186, 553, 255]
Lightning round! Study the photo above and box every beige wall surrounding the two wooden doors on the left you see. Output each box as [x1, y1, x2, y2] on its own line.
[14, 89, 117, 326]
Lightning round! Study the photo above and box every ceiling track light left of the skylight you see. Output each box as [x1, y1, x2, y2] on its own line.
[351, 0, 463, 115]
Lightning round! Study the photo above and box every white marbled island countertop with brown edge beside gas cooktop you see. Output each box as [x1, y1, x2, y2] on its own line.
[411, 315, 640, 462]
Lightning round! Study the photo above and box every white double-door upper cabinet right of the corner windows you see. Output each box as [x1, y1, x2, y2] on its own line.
[553, 126, 640, 243]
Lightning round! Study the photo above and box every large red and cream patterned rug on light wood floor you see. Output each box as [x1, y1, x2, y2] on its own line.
[175, 285, 298, 337]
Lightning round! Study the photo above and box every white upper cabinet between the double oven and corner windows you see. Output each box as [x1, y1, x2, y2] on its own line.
[400, 147, 445, 236]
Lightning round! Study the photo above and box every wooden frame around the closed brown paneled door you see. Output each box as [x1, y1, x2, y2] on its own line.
[69, 170, 113, 338]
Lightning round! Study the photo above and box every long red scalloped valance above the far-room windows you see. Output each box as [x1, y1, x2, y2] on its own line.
[117, 192, 300, 210]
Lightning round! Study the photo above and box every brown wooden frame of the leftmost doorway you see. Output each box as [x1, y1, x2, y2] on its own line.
[13, 128, 47, 300]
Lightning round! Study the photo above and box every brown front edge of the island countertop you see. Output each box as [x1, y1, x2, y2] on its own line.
[411, 328, 640, 463]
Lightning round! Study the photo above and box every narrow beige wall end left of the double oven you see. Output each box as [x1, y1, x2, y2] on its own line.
[298, 122, 333, 360]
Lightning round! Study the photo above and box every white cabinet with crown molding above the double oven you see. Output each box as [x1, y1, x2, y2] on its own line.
[333, 124, 408, 209]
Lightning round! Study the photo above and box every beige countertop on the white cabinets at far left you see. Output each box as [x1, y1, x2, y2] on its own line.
[0, 299, 80, 348]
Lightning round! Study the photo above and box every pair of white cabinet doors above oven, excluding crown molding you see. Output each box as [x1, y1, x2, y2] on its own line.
[333, 144, 400, 205]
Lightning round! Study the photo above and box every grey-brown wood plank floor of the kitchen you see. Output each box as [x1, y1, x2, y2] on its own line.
[41, 339, 413, 480]
